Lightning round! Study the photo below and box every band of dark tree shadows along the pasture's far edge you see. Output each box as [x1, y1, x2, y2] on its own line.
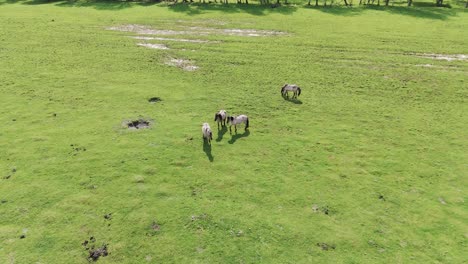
[0, 0, 465, 20]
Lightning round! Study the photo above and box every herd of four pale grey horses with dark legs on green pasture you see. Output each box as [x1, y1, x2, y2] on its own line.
[202, 84, 301, 144]
